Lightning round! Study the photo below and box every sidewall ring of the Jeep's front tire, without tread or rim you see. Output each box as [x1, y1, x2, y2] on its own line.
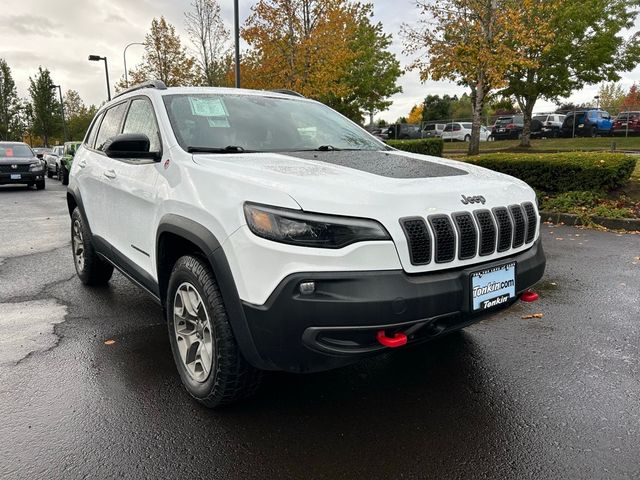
[165, 264, 220, 399]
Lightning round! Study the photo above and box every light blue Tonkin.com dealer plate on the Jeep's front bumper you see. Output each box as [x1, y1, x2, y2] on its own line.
[471, 262, 516, 311]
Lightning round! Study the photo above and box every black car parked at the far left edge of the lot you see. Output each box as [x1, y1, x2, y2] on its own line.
[0, 142, 45, 190]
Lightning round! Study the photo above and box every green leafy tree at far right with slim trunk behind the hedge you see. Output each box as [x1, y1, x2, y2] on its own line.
[504, 0, 640, 147]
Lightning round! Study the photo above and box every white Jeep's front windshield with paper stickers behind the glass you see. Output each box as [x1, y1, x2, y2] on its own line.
[164, 93, 388, 153]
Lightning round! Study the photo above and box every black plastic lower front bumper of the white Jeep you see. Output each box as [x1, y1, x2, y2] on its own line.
[243, 240, 546, 372]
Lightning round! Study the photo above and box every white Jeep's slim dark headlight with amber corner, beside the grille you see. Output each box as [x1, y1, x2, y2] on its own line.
[244, 203, 391, 248]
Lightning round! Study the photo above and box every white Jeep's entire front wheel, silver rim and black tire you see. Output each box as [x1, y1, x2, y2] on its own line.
[166, 255, 262, 408]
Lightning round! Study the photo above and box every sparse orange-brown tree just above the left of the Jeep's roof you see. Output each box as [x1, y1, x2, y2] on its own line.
[116, 17, 198, 90]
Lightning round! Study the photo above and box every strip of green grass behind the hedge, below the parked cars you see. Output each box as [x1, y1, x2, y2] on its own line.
[444, 137, 640, 154]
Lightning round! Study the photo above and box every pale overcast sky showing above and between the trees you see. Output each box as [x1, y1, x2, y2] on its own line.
[0, 0, 640, 121]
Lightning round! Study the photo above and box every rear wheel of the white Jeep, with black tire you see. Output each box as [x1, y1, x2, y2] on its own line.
[71, 207, 113, 286]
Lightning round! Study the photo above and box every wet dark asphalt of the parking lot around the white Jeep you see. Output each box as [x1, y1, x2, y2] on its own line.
[0, 180, 640, 479]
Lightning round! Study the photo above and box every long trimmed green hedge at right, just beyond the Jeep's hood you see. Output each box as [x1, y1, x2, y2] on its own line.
[466, 152, 636, 193]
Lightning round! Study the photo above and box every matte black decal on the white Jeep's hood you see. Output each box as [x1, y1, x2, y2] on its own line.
[285, 151, 467, 178]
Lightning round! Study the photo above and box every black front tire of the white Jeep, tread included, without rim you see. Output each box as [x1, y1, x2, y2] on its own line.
[165, 255, 262, 408]
